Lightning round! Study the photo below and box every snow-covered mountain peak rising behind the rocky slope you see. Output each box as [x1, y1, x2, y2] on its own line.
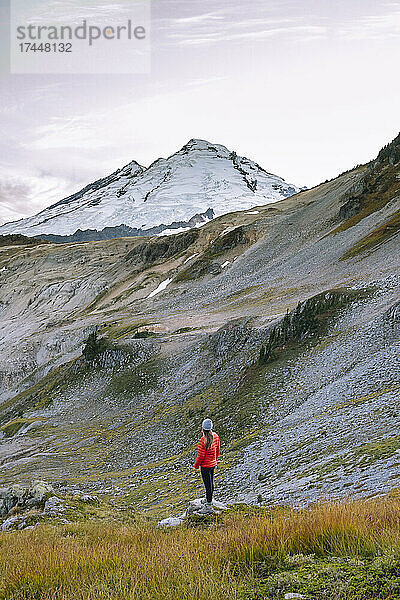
[0, 139, 299, 237]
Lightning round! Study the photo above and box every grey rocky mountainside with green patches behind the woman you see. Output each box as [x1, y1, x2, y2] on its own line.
[0, 134, 400, 517]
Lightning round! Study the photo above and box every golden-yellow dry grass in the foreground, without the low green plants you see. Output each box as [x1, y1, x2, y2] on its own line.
[0, 496, 400, 600]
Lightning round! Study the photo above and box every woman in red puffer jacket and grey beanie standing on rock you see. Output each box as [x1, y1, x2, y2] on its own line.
[194, 419, 220, 510]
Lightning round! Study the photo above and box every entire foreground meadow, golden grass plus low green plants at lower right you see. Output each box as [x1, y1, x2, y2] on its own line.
[0, 495, 400, 600]
